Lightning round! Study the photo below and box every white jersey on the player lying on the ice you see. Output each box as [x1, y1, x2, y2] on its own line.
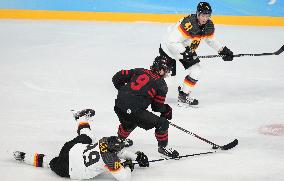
[69, 138, 137, 181]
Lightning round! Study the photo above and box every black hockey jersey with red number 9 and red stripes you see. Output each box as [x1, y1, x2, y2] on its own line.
[112, 68, 168, 114]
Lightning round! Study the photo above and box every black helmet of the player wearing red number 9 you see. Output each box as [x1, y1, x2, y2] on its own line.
[150, 55, 172, 73]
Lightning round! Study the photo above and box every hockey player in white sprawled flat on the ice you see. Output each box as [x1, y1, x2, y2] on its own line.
[13, 109, 149, 181]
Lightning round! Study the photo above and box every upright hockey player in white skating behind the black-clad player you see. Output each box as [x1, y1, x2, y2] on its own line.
[159, 2, 233, 107]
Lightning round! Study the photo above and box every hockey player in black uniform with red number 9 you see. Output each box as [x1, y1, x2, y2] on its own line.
[112, 56, 179, 157]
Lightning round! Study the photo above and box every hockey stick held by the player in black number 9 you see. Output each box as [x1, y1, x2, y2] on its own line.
[170, 122, 239, 150]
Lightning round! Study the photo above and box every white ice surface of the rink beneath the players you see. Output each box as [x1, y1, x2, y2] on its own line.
[0, 20, 284, 181]
